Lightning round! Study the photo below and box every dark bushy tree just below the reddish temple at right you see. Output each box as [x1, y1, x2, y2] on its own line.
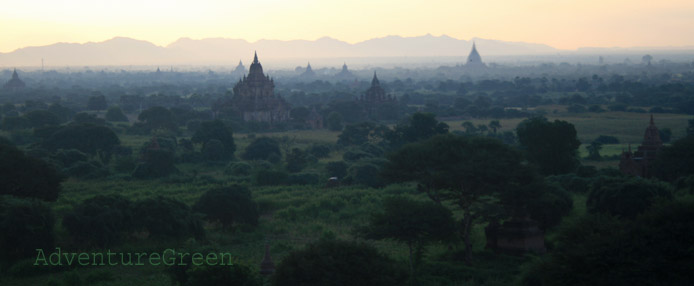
[586, 177, 672, 218]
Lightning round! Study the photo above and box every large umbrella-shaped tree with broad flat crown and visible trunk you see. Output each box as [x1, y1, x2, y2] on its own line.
[382, 135, 523, 263]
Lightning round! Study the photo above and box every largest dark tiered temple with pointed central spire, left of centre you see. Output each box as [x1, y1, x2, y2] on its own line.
[231, 53, 290, 123]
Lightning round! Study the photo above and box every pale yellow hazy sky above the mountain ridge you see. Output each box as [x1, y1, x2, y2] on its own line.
[0, 0, 694, 52]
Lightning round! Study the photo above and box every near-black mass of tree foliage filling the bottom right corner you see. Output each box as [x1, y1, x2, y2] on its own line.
[519, 199, 694, 286]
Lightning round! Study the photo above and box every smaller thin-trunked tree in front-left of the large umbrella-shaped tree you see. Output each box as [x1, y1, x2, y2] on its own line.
[359, 197, 455, 282]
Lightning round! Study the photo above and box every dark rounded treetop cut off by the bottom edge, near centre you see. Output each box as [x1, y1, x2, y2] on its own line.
[273, 240, 406, 286]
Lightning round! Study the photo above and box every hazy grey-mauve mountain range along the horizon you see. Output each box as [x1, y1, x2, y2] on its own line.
[0, 34, 694, 67]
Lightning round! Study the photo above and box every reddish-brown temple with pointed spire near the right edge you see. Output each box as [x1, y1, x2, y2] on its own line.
[619, 115, 663, 178]
